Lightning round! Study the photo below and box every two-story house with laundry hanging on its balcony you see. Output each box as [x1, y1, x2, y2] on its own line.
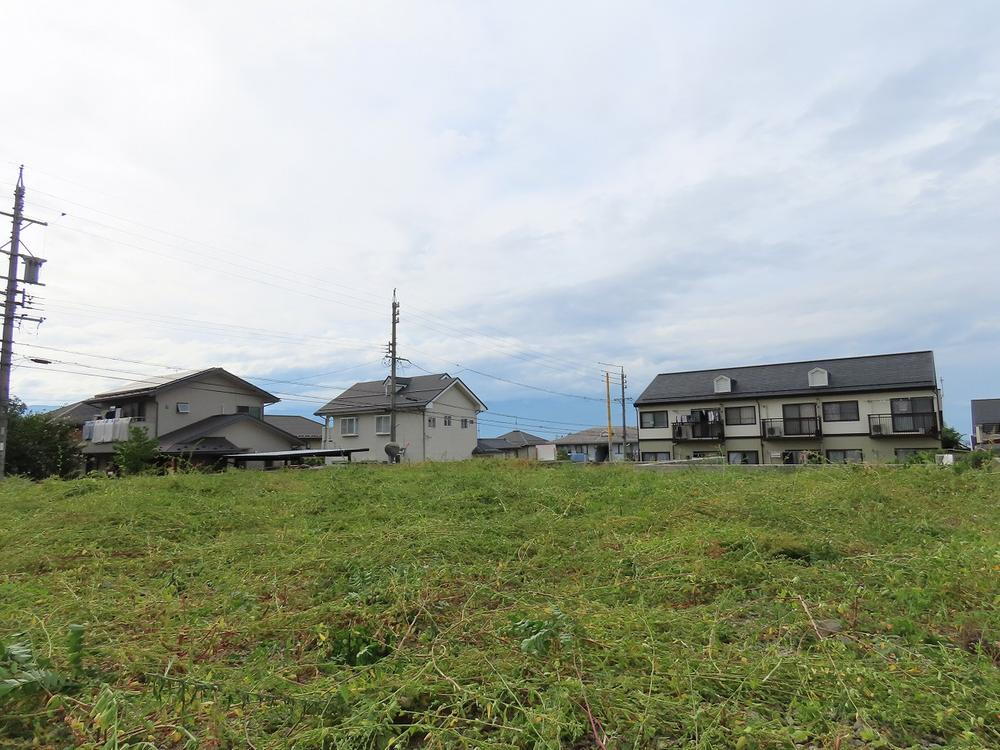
[82, 367, 302, 470]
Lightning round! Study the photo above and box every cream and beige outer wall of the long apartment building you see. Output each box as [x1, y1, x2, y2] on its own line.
[639, 389, 941, 464]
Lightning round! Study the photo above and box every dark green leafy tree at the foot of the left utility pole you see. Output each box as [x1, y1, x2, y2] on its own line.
[6, 398, 81, 479]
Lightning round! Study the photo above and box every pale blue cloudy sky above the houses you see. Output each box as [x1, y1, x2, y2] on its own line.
[0, 0, 1000, 437]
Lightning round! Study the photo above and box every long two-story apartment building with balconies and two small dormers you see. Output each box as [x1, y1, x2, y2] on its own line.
[635, 351, 942, 464]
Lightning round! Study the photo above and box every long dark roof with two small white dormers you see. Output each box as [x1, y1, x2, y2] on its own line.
[635, 351, 937, 406]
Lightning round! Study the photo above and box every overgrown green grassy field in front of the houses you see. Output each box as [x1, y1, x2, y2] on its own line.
[0, 462, 1000, 750]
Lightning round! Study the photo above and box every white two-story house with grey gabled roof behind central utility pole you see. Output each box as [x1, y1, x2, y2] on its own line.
[316, 373, 486, 463]
